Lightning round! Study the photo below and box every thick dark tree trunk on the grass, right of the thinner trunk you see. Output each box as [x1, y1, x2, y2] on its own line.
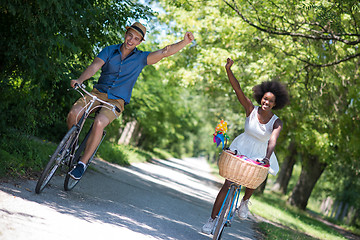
[288, 155, 327, 210]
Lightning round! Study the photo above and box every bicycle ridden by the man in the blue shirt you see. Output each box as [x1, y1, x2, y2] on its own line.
[35, 84, 121, 194]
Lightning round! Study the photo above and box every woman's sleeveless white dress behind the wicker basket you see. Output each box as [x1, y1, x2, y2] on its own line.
[230, 106, 279, 176]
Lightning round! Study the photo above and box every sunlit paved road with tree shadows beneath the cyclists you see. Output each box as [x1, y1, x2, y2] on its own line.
[0, 158, 256, 240]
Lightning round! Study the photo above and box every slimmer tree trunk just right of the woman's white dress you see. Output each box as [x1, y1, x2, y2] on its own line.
[271, 141, 297, 194]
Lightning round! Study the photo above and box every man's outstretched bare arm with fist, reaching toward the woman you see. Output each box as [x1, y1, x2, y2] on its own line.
[147, 32, 194, 65]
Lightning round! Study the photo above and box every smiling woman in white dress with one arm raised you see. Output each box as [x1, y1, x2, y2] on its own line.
[202, 58, 289, 234]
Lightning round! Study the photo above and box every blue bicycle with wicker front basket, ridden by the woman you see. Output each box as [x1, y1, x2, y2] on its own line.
[213, 149, 268, 240]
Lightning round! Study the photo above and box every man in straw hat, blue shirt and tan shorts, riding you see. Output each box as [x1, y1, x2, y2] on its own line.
[67, 22, 194, 180]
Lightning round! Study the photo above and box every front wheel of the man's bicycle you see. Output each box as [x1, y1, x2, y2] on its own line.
[35, 126, 78, 194]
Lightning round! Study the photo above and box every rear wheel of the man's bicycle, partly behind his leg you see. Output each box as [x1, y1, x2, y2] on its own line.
[64, 127, 106, 191]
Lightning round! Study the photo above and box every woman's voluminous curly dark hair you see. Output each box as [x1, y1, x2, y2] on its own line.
[253, 81, 289, 110]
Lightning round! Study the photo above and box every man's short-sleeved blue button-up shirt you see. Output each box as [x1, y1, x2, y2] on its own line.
[94, 44, 150, 104]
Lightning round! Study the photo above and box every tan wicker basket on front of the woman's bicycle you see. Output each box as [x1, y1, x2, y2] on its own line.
[219, 151, 269, 189]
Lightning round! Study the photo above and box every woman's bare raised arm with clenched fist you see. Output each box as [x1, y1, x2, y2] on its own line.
[225, 58, 254, 117]
